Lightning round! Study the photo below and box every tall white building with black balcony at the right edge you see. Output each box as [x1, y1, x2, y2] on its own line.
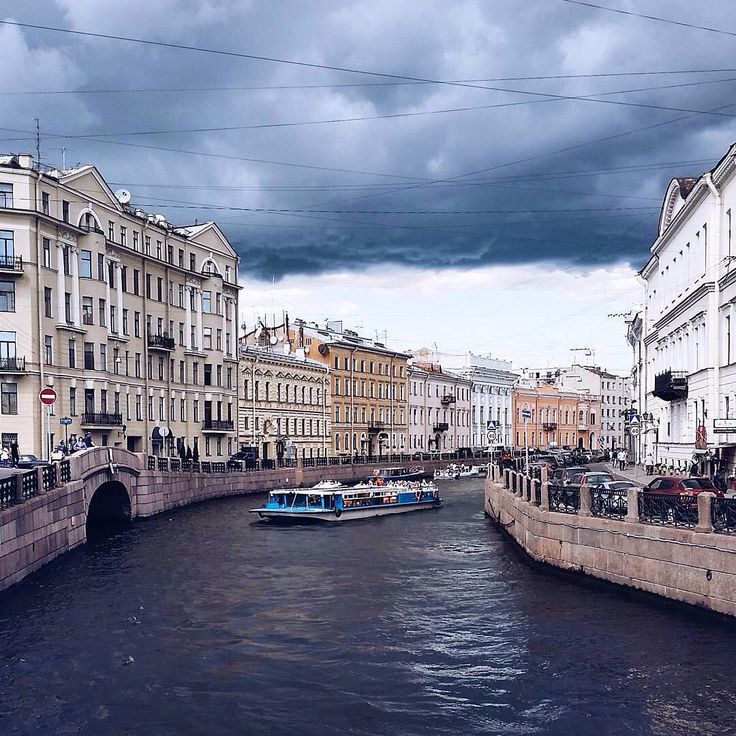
[630, 146, 736, 473]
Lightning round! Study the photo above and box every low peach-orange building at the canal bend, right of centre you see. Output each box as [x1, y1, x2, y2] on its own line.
[513, 378, 600, 450]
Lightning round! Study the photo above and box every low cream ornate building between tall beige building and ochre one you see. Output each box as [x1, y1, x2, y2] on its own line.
[238, 338, 331, 460]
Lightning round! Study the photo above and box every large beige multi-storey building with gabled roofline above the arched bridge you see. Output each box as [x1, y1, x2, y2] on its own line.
[0, 155, 239, 460]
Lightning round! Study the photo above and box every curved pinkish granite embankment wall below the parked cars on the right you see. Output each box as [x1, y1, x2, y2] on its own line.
[484, 468, 736, 616]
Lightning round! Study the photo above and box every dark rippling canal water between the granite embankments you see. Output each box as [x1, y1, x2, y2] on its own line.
[0, 480, 736, 736]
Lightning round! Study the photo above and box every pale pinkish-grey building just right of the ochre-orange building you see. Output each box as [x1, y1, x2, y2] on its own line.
[408, 360, 473, 452]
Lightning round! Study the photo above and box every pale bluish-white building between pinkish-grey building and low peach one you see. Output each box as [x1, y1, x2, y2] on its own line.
[415, 348, 518, 448]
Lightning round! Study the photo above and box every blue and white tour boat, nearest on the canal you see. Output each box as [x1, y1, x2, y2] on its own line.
[250, 481, 442, 523]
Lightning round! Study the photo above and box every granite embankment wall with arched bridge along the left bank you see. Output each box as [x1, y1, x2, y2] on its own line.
[0, 447, 454, 590]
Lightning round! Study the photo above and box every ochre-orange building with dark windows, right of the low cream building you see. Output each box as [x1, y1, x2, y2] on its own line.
[286, 320, 410, 458]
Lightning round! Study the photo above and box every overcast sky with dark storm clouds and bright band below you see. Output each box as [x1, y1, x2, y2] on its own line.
[0, 0, 736, 371]
